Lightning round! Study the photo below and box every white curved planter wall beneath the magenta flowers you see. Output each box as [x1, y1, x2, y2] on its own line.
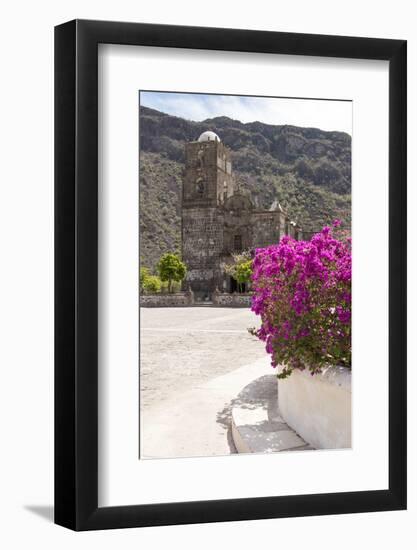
[278, 367, 352, 449]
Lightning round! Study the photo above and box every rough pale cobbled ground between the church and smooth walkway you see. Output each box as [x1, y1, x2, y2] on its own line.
[140, 306, 265, 409]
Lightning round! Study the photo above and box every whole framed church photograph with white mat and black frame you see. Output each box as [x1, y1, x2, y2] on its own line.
[55, 20, 406, 530]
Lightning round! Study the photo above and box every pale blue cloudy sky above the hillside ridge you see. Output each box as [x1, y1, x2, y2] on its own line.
[140, 92, 352, 135]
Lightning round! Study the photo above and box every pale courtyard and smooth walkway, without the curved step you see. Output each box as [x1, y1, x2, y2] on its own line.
[140, 306, 271, 458]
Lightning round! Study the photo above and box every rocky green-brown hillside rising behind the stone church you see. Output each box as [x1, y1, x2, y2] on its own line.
[140, 107, 351, 268]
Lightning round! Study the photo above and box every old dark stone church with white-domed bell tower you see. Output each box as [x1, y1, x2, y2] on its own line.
[182, 131, 301, 300]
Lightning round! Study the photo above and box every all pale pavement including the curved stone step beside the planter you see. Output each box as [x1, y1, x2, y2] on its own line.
[140, 308, 307, 458]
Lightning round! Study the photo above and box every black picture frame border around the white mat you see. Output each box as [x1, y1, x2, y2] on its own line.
[55, 20, 407, 530]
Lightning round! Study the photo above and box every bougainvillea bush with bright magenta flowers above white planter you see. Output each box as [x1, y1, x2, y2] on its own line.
[252, 220, 352, 378]
